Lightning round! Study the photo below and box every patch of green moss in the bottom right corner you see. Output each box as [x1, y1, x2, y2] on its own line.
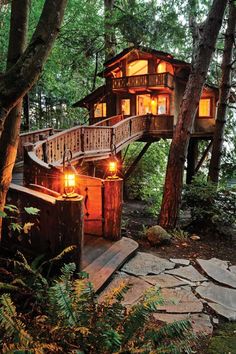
[207, 323, 236, 354]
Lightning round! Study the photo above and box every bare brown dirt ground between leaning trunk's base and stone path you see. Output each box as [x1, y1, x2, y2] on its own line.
[122, 201, 236, 264]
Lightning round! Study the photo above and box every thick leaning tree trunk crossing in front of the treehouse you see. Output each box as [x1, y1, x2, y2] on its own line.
[159, 0, 227, 229]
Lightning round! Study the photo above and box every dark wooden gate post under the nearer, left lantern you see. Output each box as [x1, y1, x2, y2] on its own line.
[55, 195, 84, 271]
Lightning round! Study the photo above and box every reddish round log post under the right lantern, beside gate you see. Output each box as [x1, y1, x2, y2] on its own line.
[103, 178, 123, 241]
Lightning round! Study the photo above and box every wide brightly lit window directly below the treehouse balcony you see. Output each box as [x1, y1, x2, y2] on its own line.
[136, 95, 169, 115]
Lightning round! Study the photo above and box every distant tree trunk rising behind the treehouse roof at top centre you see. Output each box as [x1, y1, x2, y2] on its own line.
[104, 0, 116, 60]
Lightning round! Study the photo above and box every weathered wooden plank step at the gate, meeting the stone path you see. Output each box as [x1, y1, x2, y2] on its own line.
[83, 237, 139, 291]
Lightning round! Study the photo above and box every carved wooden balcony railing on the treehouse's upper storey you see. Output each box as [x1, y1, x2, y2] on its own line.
[111, 73, 174, 91]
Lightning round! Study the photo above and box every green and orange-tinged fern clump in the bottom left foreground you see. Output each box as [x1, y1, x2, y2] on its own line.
[0, 254, 195, 354]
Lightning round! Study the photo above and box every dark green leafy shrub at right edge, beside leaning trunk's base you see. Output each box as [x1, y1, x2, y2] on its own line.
[182, 175, 236, 235]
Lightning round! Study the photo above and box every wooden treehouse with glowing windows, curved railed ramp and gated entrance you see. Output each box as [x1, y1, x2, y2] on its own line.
[8, 48, 218, 289]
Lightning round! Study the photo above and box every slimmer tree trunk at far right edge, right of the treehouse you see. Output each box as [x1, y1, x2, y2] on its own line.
[208, 1, 236, 183]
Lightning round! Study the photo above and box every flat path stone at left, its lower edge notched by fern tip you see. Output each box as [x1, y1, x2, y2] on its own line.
[98, 275, 151, 306]
